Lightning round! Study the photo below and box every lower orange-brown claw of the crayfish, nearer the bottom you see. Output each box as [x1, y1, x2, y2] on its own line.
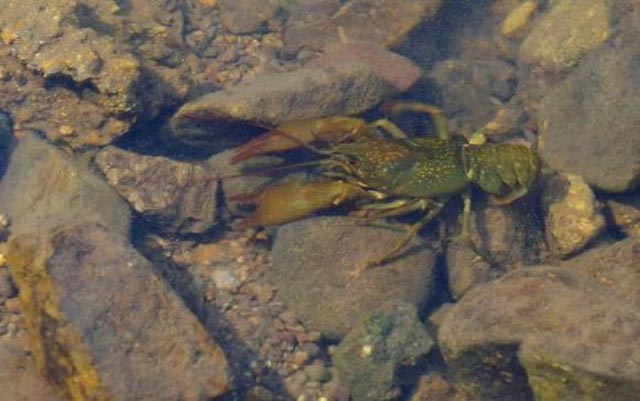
[235, 181, 369, 230]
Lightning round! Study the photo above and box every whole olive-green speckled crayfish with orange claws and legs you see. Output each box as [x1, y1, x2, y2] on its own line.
[228, 102, 540, 274]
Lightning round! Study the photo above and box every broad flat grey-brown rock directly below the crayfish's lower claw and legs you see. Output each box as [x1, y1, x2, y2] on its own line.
[265, 217, 435, 339]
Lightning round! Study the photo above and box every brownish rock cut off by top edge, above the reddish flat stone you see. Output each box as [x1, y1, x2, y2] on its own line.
[283, 0, 441, 55]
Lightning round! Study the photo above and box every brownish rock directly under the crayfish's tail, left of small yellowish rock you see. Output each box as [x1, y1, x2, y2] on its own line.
[447, 199, 544, 299]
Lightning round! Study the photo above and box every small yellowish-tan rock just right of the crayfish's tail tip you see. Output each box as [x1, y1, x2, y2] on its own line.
[542, 174, 606, 257]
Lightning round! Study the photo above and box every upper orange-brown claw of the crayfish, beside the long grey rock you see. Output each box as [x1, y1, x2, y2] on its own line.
[231, 116, 371, 163]
